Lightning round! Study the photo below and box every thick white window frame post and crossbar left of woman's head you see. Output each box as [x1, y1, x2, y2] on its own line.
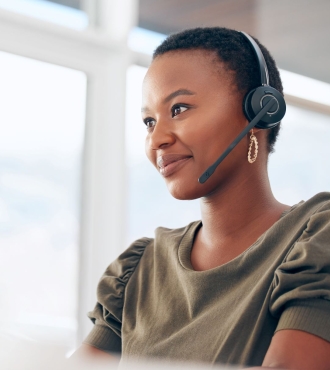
[0, 0, 137, 344]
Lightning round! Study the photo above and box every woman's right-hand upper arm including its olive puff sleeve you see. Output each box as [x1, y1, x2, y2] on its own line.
[263, 204, 330, 370]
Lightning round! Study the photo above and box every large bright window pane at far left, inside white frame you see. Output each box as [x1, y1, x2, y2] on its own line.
[0, 52, 86, 347]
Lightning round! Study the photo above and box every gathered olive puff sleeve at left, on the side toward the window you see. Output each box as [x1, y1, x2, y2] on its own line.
[84, 238, 151, 353]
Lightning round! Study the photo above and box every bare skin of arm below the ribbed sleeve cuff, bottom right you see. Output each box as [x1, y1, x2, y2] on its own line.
[262, 329, 330, 370]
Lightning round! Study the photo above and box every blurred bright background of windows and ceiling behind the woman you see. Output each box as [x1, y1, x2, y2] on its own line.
[0, 0, 330, 350]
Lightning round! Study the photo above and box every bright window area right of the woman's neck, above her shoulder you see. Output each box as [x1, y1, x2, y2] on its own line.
[269, 105, 330, 205]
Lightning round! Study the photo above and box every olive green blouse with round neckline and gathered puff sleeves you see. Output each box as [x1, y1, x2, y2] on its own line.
[85, 193, 330, 366]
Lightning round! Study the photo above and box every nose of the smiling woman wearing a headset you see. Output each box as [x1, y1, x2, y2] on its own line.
[146, 120, 176, 150]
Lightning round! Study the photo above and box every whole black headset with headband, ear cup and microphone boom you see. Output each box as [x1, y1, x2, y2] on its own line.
[198, 31, 286, 184]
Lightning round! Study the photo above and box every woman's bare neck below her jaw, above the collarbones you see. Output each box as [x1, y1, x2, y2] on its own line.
[199, 169, 288, 249]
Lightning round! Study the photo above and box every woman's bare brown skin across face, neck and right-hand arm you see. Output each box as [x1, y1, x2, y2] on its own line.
[142, 50, 330, 370]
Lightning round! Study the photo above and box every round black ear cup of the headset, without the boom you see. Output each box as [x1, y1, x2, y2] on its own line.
[244, 85, 286, 129]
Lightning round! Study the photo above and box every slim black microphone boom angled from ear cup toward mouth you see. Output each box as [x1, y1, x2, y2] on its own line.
[198, 97, 278, 184]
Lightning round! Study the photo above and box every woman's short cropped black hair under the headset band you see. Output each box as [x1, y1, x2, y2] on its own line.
[153, 27, 283, 153]
